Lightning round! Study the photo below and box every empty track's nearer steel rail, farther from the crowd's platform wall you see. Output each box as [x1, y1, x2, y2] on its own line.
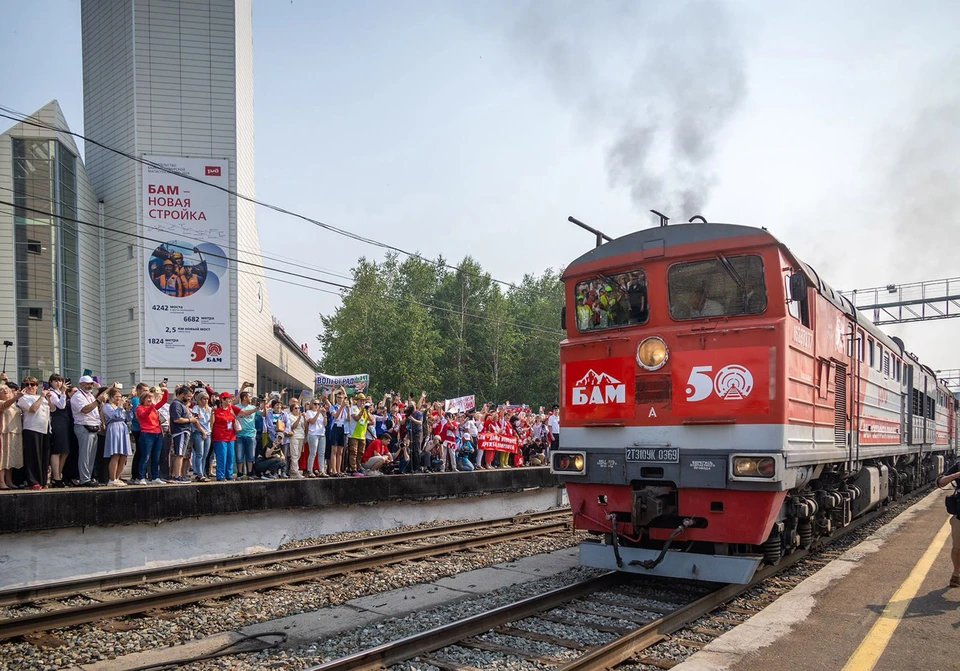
[0, 520, 570, 640]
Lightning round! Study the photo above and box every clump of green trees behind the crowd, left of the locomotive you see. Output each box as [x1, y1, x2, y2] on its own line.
[317, 253, 564, 408]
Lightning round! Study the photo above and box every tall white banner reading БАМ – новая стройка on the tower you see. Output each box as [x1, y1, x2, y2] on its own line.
[142, 156, 233, 368]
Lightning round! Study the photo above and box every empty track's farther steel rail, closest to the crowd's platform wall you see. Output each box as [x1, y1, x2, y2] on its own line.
[0, 508, 570, 606]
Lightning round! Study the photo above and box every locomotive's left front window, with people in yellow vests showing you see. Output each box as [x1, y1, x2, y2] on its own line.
[576, 270, 650, 333]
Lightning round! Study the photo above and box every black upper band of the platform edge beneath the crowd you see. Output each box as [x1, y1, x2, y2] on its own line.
[0, 466, 557, 543]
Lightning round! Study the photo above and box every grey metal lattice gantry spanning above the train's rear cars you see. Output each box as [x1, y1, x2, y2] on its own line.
[840, 277, 960, 326]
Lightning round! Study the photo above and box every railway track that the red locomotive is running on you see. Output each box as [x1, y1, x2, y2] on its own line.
[309, 488, 929, 671]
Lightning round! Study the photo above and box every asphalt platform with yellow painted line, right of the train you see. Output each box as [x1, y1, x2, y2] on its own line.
[674, 490, 960, 671]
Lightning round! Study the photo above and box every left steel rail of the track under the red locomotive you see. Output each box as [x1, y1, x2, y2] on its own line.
[308, 571, 626, 671]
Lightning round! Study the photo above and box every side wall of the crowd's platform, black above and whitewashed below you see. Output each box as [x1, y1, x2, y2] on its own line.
[0, 467, 567, 592]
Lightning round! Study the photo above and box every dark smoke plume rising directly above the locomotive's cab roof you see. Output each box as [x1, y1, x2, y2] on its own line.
[512, 0, 746, 220]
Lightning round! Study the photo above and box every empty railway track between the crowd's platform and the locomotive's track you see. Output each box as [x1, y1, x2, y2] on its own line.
[0, 510, 570, 641]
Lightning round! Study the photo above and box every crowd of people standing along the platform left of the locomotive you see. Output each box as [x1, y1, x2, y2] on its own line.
[0, 374, 560, 491]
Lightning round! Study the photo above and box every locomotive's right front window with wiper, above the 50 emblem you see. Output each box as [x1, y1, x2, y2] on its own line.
[667, 255, 767, 319]
